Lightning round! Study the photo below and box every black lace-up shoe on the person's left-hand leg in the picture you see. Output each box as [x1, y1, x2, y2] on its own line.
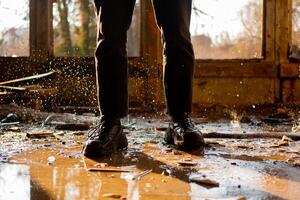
[83, 117, 128, 157]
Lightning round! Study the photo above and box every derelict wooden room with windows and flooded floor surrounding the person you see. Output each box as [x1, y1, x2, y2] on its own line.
[0, 0, 300, 200]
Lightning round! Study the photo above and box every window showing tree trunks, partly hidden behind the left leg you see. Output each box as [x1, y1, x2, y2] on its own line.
[53, 0, 140, 57]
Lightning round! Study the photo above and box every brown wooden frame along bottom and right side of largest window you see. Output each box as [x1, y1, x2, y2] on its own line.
[195, 0, 277, 78]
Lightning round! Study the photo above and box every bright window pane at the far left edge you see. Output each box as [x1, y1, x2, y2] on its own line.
[0, 0, 29, 57]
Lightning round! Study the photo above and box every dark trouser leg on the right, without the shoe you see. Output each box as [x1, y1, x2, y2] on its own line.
[153, 0, 194, 116]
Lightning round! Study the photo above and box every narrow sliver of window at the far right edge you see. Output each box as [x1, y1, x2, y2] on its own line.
[290, 0, 300, 60]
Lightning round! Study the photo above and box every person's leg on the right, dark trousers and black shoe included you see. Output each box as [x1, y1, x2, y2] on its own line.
[153, 0, 204, 148]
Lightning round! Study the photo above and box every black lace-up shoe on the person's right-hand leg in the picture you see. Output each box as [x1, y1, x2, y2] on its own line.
[164, 116, 205, 149]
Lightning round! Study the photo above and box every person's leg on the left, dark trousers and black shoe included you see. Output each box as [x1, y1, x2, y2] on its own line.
[83, 0, 135, 157]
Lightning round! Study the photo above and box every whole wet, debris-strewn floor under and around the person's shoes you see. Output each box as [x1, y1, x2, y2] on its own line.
[0, 117, 300, 200]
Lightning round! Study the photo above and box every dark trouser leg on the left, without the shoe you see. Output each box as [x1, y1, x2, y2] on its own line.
[94, 0, 135, 118]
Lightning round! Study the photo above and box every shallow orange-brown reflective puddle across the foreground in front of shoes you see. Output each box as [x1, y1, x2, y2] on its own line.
[0, 144, 300, 199]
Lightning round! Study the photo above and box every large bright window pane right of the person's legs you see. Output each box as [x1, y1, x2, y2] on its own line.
[190, 0, 263, 59]
